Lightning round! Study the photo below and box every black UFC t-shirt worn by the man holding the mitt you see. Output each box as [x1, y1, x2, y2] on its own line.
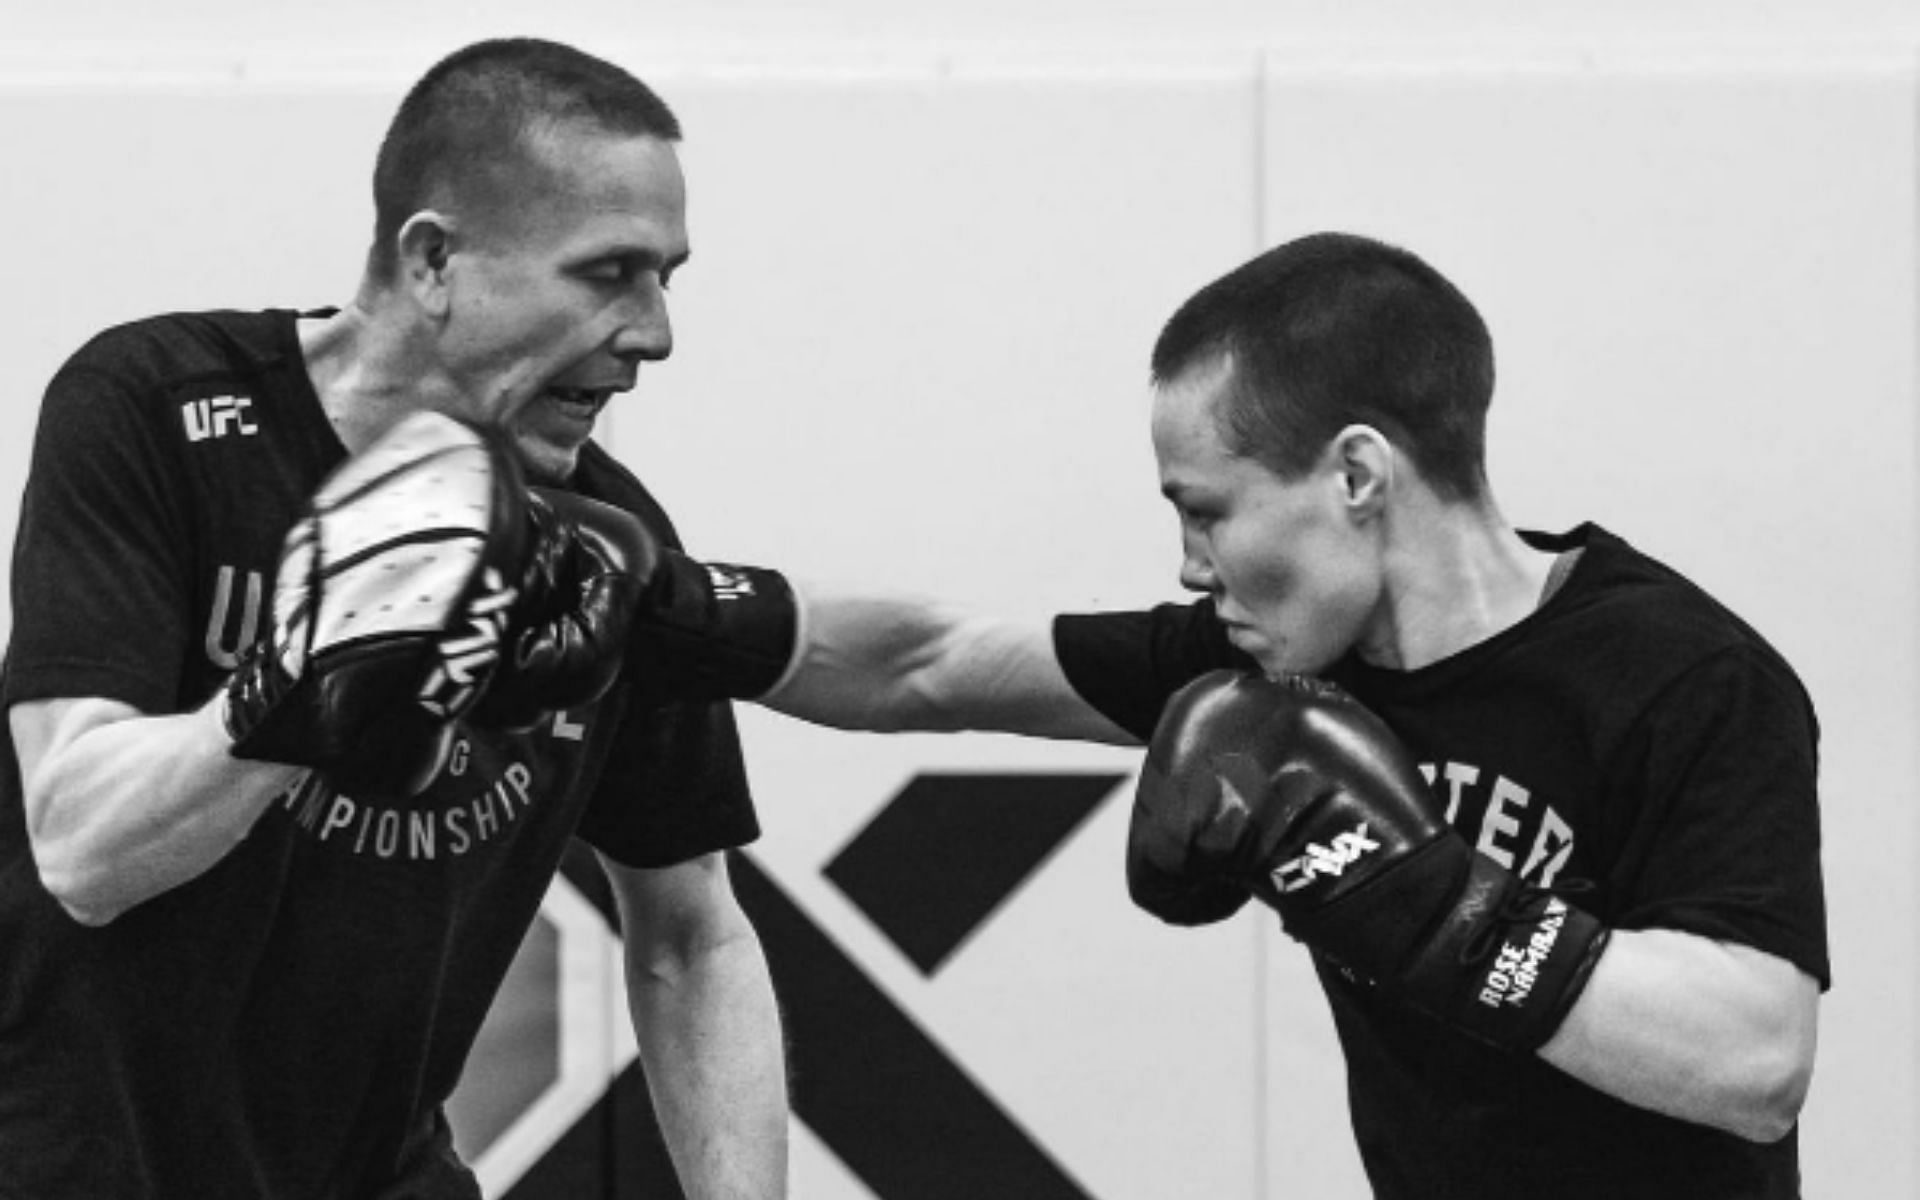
[0, 311, 758, 1200]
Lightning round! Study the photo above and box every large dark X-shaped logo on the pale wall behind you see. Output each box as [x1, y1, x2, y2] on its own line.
[455, 772, 1127, 1200]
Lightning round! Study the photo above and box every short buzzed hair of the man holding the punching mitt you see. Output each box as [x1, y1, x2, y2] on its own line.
[367, 38, 680, 280]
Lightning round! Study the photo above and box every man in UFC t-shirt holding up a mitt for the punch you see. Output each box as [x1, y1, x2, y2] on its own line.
[0, 38, 787, 1200]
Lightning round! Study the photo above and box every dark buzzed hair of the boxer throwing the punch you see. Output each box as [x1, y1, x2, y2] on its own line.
[1152, 232, 1494, 501]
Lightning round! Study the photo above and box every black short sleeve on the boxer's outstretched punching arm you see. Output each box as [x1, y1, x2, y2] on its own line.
[1054, 601, 1254, 741]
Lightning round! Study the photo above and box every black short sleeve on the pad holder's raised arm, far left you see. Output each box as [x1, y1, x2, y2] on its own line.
[4, 351, 192, 712]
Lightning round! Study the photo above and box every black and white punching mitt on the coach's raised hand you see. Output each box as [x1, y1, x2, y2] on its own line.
[221, 413, 528, 797]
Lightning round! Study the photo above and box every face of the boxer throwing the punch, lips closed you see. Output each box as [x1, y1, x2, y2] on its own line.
[1152, 363, 1382, 674]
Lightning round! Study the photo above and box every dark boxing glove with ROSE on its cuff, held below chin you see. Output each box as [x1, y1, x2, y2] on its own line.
[1127, 670, 1609, 1050]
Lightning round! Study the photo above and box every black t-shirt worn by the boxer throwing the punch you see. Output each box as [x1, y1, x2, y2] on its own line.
[1054, 526, 1828, 1200]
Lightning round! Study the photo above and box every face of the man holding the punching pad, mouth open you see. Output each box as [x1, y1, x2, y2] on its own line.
[442, 125, 687, 482]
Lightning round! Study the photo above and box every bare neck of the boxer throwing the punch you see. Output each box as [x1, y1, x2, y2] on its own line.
[1357, 497, 1553, 670]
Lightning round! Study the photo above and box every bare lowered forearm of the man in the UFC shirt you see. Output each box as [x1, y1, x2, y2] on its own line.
[628, 929, 787, 1200]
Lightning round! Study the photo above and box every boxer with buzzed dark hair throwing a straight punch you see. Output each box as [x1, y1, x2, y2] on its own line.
[762, 234, 1828, 1200]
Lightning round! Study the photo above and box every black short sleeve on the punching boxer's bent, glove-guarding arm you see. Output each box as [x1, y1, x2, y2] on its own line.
[1609, 647, 1832, 987]
